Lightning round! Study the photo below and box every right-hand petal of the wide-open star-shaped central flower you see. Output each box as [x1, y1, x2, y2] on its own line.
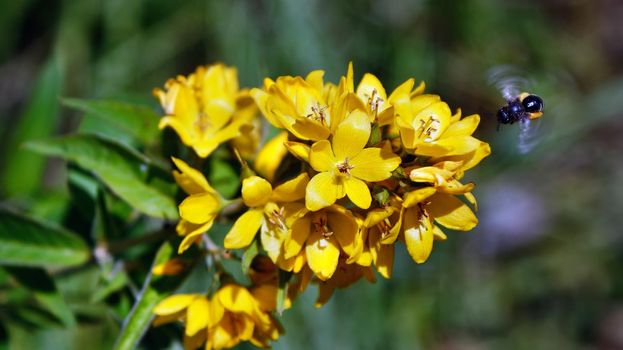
[349, 147, 400, 182]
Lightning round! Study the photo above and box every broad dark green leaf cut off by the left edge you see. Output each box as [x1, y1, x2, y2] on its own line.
[0, 209, 90, 267]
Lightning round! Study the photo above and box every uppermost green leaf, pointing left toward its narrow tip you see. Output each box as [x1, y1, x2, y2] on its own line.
[62, 98, 160, 144]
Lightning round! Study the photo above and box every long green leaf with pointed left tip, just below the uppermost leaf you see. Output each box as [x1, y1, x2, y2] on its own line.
[26, 135, 177, 219]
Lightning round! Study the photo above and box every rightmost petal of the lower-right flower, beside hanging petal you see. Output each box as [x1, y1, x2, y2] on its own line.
[426, 193, 478, 231]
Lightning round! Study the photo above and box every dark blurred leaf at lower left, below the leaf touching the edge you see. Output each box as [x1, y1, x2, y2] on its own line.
[5, 267, 76, 327]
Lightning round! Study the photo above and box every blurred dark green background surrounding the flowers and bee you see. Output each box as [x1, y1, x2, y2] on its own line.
[0, 0, 623, 350]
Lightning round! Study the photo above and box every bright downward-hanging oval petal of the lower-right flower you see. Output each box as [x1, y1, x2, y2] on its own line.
[403, 209, 433, 264]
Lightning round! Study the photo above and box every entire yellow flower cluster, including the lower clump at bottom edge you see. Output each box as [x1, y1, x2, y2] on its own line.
[156, 64, 490, 348]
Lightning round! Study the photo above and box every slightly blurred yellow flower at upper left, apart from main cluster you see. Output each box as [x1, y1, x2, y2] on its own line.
[154, 64, 256, 158]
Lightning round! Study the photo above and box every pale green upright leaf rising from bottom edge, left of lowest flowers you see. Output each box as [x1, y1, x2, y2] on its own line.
[114, 242, 186, 350]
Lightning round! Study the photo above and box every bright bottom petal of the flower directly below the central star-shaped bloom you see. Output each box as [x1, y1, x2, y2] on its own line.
[305, 232, 340, 281]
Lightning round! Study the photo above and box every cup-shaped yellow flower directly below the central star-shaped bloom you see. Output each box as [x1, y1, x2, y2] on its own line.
[284, 205, 361, 280]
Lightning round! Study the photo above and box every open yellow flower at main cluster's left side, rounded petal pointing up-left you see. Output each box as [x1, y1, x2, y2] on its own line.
[224, 173, 309, 261]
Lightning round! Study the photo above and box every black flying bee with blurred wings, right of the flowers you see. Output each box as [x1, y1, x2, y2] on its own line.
[488, 66, 544, 154]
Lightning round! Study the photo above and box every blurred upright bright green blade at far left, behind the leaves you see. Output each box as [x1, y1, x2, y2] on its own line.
[0, 57, 63, 196]
